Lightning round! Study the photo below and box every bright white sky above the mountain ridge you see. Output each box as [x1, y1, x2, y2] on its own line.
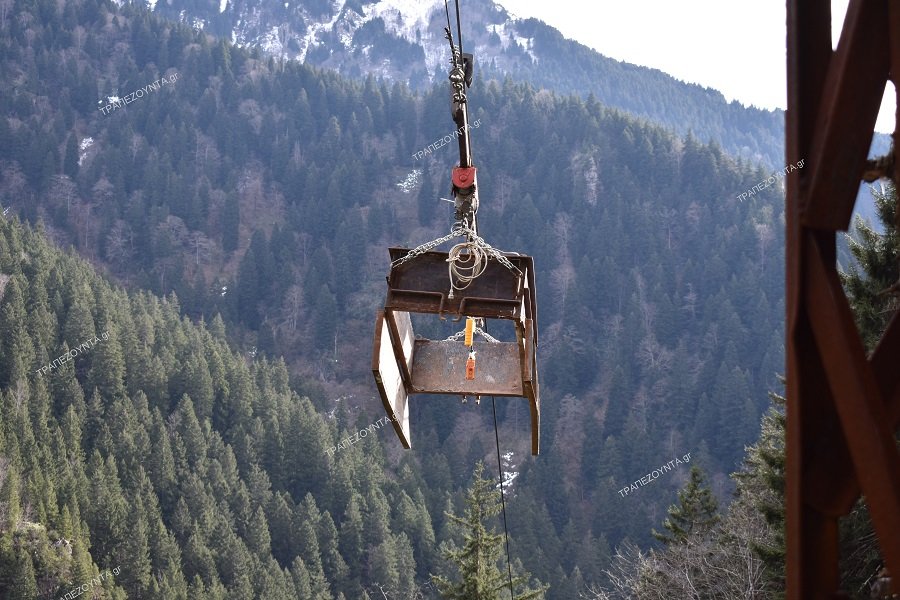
[497, 0, 895, 133]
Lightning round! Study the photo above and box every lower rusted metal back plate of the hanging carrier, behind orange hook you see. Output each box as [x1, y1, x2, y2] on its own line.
[409, 340, 525, 396]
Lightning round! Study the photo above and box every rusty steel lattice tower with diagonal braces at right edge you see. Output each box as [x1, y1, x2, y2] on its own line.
[785, 0, 900, 600]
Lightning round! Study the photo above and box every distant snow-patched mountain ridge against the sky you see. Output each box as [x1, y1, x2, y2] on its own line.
[144, 0, 784, 168]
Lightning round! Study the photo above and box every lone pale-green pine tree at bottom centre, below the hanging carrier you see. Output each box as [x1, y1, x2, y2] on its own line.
[432, 461, 549, 600]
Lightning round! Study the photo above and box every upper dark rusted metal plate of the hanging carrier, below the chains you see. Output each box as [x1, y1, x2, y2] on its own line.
[385, 248, 535, 320]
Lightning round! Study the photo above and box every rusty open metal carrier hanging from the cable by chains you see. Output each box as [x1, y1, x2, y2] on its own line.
[372, 248, 540, 455]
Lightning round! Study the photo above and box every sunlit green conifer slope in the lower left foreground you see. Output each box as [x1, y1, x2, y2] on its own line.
[0, 213, 458, 600]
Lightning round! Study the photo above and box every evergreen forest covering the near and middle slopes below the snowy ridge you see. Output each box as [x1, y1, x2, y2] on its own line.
[0, 0, 897, 600]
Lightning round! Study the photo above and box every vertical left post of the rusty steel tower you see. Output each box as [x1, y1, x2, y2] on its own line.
[785, 0, 838, 600]
